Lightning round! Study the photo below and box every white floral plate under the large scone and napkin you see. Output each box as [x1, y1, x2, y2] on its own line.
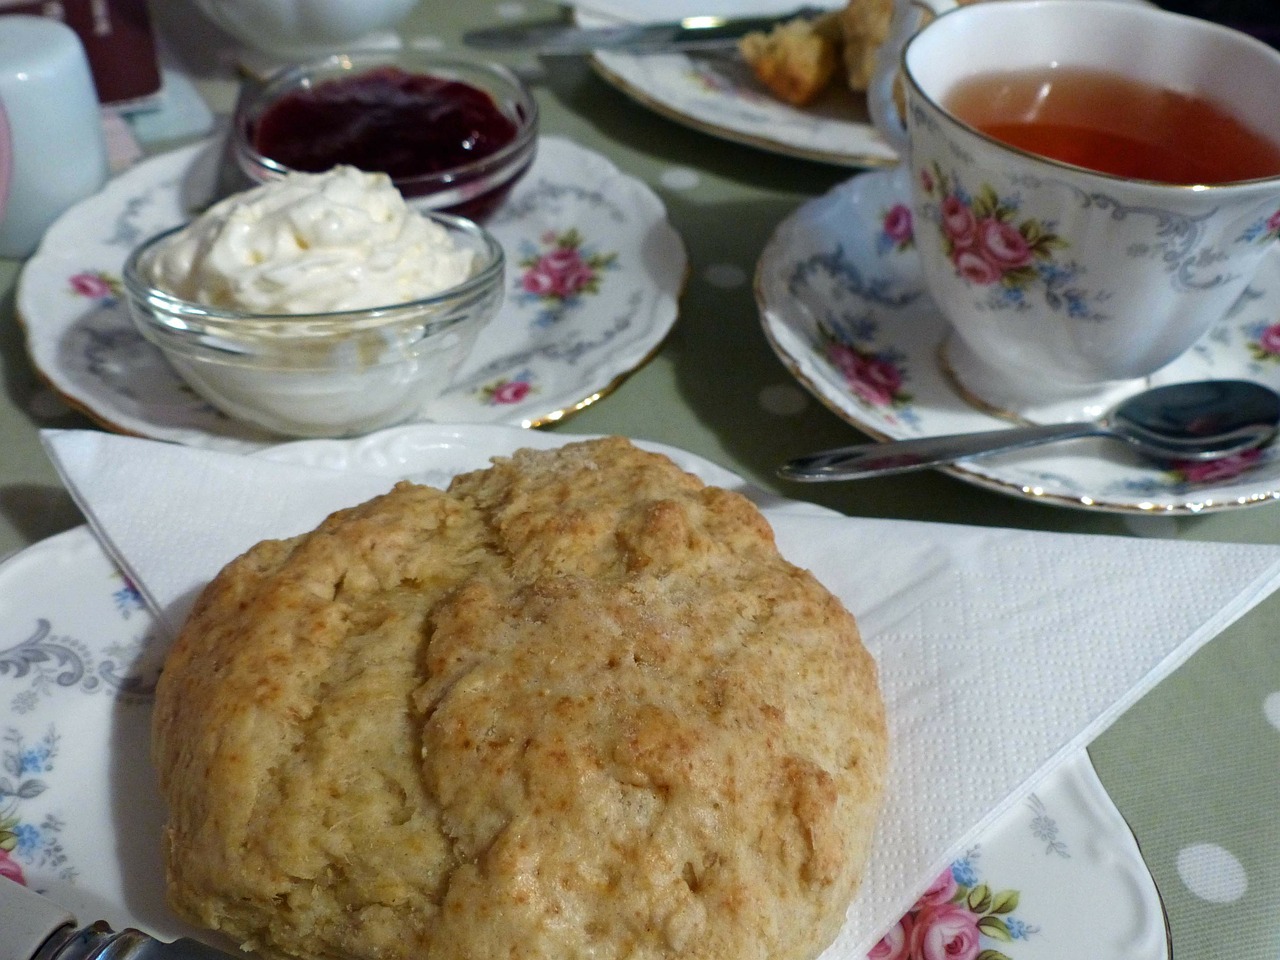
[0, 425, 1169, 960]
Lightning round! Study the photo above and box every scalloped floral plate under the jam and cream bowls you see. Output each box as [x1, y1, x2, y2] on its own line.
[17, 137, 686, 451]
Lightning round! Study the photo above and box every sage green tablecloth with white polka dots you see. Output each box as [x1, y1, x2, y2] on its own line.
[0, 0, 1280, 960]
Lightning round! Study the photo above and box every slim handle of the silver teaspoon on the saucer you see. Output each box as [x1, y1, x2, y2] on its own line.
[778, 421, 1111, 483]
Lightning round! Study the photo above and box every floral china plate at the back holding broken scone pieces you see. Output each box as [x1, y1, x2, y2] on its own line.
[576, 10, 897, 166]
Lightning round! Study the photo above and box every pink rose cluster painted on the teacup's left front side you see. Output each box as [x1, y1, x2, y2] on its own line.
[919, 164, 1105, 319]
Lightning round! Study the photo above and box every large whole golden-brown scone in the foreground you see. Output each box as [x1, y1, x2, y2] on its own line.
[154, 438, 886, 960]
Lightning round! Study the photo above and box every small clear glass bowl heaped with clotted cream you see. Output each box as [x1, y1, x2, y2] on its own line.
[123, 166, 504, 436]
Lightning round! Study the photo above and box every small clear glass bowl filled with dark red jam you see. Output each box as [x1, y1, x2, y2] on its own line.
[232, 50, 538, 220]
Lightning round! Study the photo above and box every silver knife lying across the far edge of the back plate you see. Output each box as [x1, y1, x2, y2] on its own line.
[462, 6, 826, 56]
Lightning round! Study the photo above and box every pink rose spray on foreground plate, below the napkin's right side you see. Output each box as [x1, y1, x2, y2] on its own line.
[867, 856, 1038, 960]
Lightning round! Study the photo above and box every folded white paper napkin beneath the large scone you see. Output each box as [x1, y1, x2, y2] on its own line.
[45, 431, 1280, 960]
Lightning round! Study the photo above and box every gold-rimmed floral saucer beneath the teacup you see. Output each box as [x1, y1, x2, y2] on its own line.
[755, 170, 1280, 515]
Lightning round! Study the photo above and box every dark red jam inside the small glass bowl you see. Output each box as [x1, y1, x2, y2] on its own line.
[253, 67, 517, 196]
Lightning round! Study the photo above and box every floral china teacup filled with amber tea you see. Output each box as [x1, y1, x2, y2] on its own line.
[870, 0, 1280, 415]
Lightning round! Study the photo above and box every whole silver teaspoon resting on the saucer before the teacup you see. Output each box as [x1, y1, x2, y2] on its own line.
[778, 380, 1280, 483]
